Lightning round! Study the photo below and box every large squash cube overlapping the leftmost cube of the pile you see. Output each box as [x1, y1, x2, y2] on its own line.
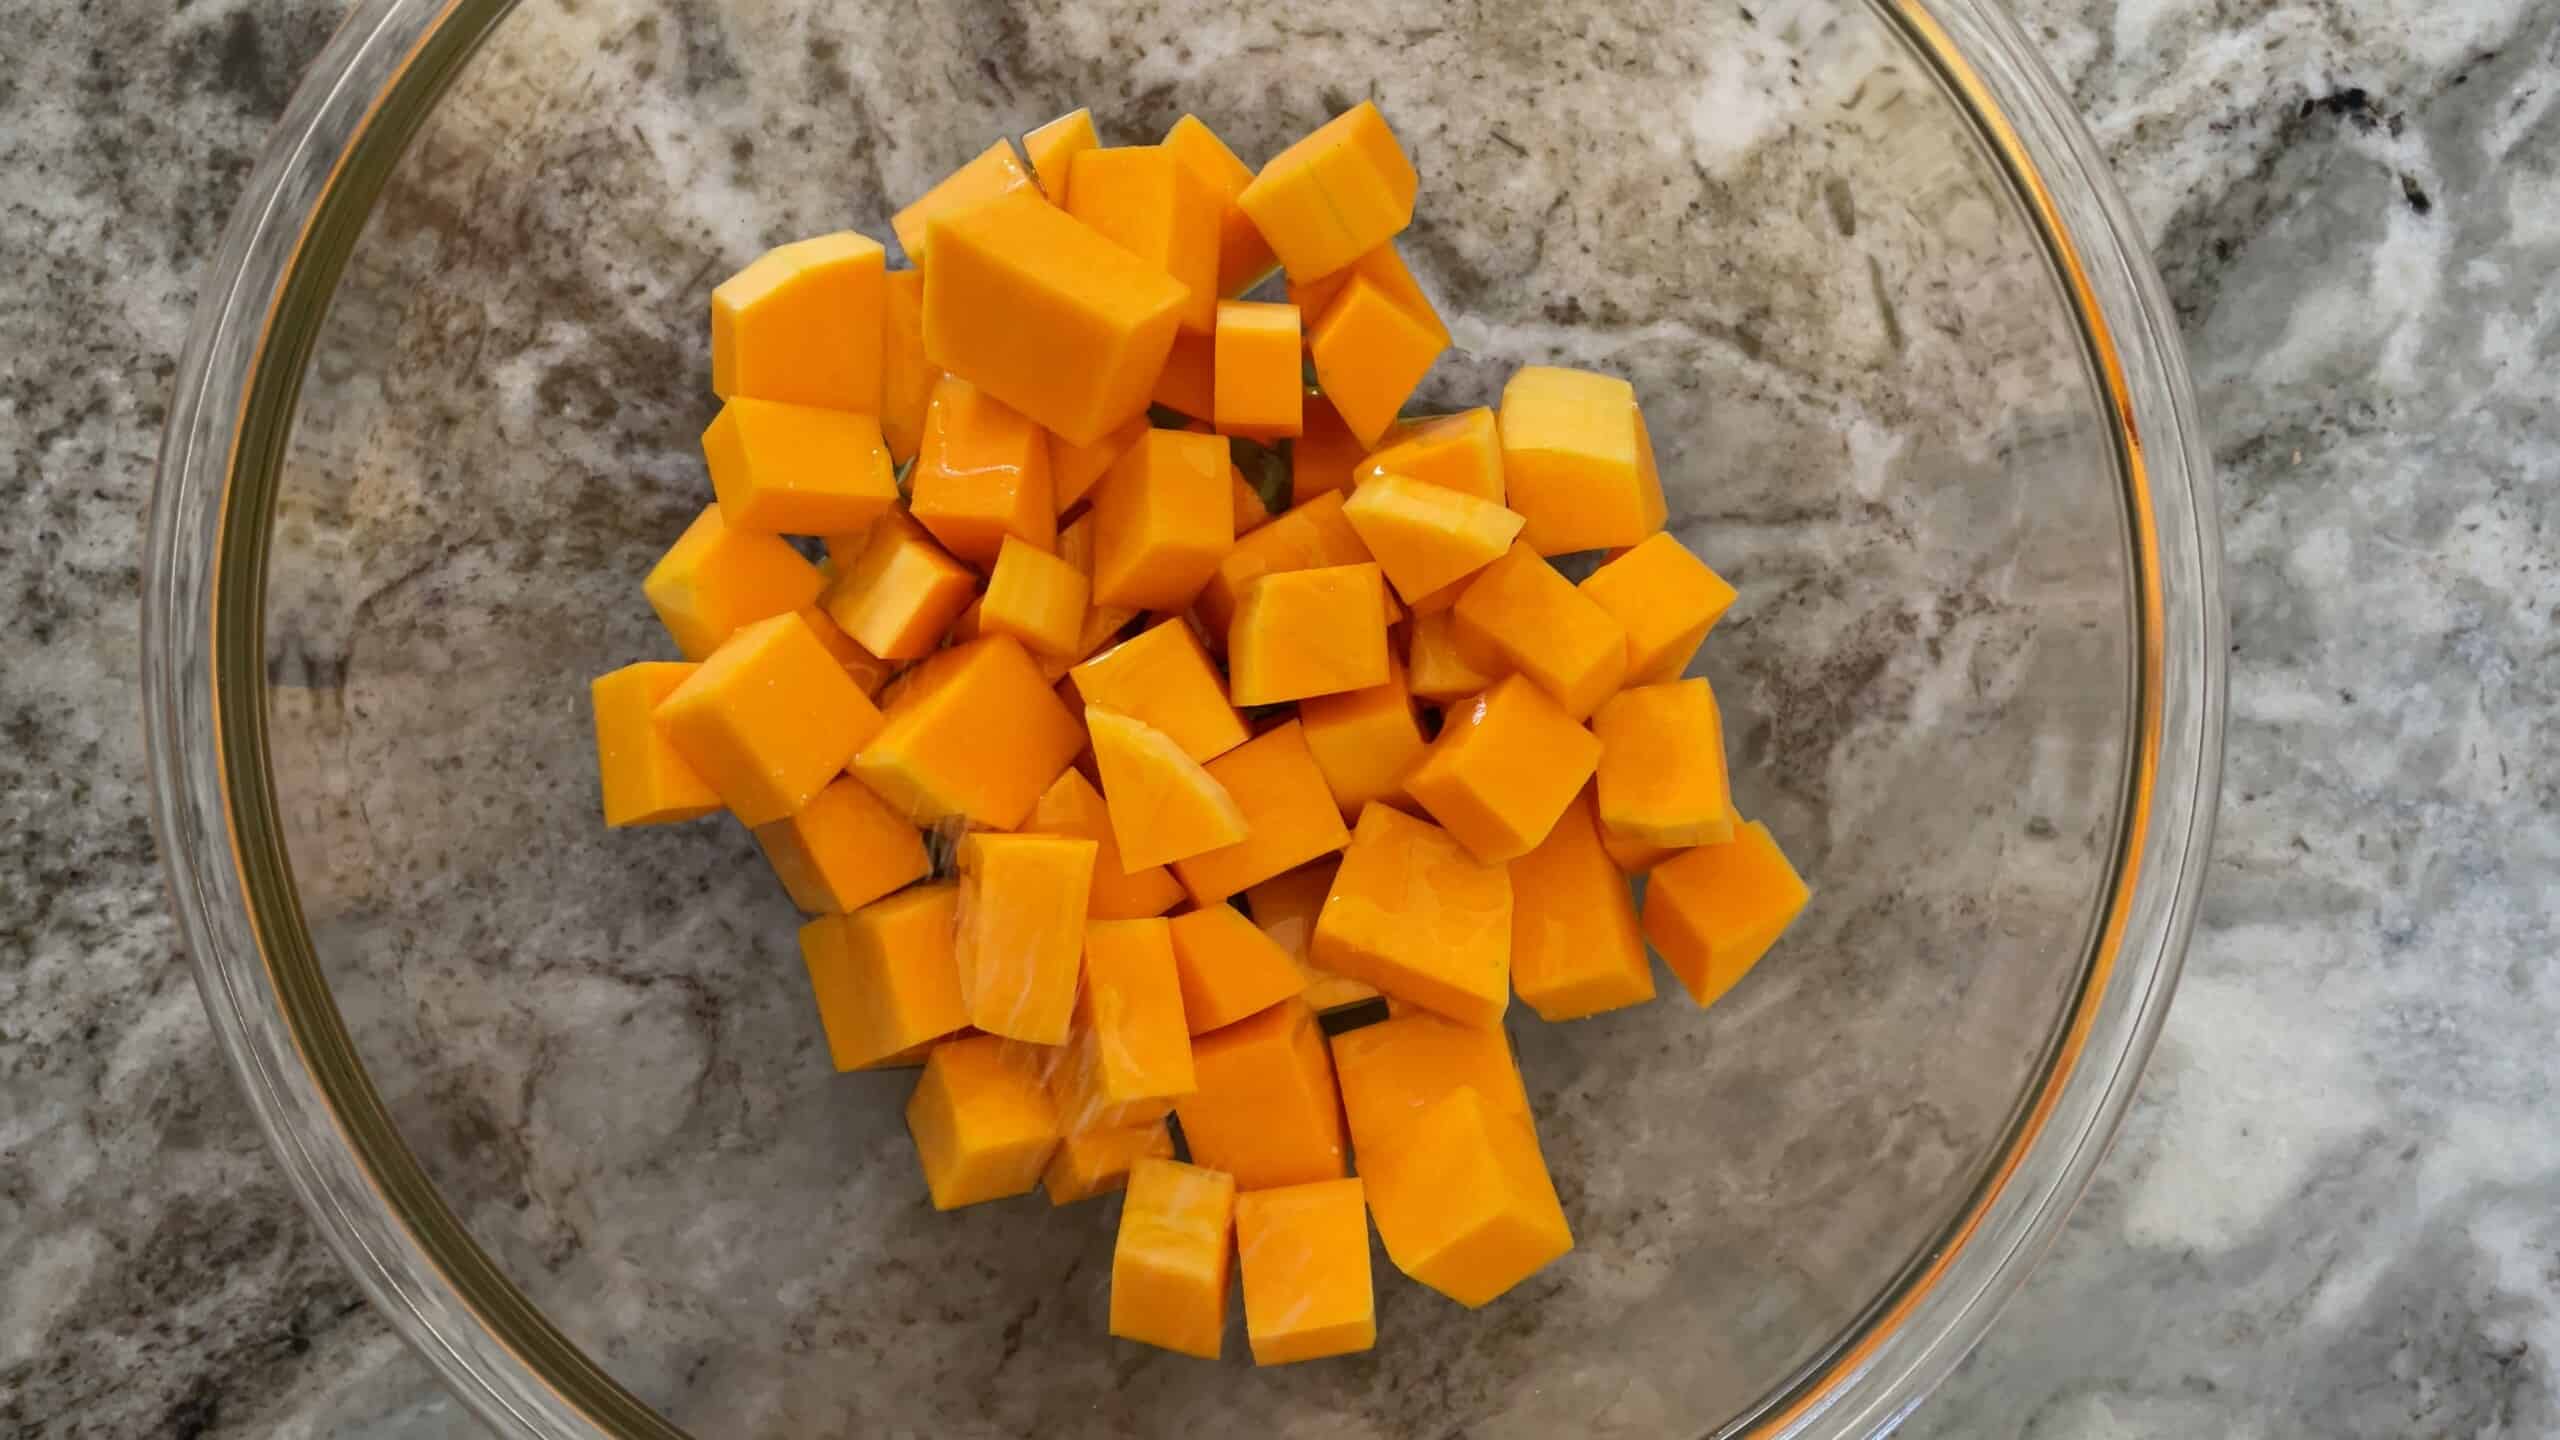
[653, 615, 881, 828]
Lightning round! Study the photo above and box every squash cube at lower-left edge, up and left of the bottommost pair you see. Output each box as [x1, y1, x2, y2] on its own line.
[906, 1035, 1057, 1209]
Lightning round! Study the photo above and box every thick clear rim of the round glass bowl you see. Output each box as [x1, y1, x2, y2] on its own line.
[143, 0, 2227, 1440]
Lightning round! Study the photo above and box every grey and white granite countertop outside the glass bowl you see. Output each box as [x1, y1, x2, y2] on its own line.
[0, 0, 2560, 1440]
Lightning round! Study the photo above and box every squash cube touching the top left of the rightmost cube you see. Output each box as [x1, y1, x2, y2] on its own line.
[1592, 679, 1733, 846]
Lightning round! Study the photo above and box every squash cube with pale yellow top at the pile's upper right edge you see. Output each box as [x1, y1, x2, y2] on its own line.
[1500, 364, 1669, 556]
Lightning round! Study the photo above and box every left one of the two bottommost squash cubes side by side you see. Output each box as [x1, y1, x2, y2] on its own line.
[1111, 1158, 1236, 1361]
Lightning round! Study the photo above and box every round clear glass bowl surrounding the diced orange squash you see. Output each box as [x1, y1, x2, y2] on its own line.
[143, 0, 2222, 1437]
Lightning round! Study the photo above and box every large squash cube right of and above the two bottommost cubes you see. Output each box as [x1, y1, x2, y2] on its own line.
[1359, 1086, 1574, 1309]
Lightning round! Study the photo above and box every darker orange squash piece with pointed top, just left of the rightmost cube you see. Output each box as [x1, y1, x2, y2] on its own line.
[1505, 787, 1654, 1019]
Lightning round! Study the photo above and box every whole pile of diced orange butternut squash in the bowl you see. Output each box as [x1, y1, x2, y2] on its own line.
[594, 102, 1807, 1363]
